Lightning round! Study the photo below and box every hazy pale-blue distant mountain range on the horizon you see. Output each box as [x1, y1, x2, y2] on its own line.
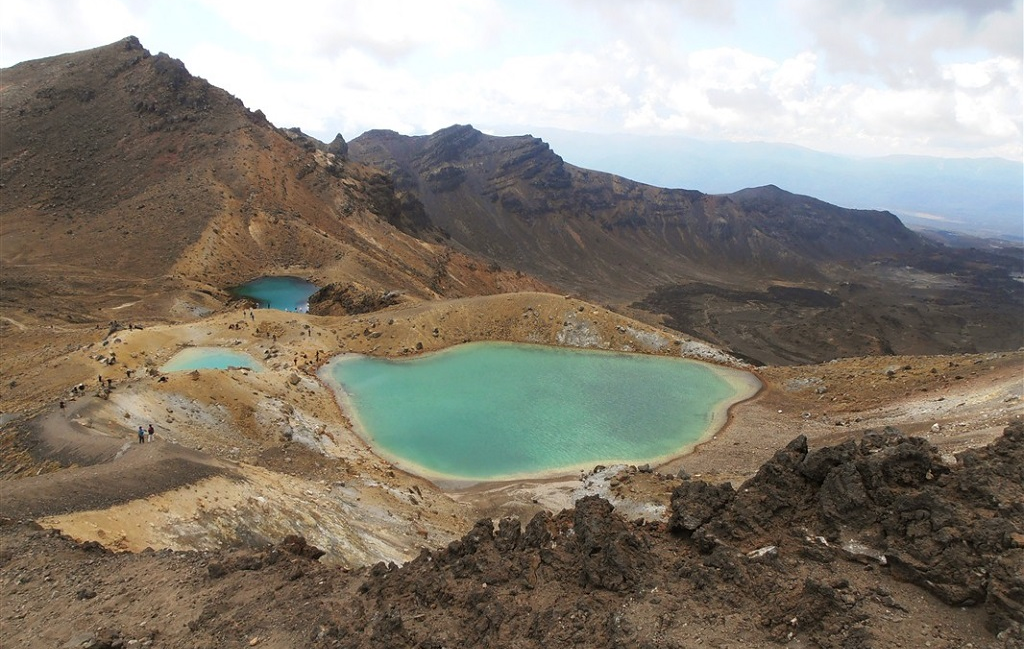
[512, 128, 1024, 243]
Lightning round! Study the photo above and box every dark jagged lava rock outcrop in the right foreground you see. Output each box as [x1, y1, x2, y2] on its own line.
[688, 423, 1024, 629]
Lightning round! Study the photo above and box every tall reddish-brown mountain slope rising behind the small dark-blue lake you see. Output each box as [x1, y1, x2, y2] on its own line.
[0, 38, 540, 321]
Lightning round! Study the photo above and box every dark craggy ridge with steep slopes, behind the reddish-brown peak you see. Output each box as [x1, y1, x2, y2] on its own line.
[350, 126, 930, 295]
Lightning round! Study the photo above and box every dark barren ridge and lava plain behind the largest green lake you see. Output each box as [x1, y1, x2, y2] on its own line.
[349, 126, 1024, 363]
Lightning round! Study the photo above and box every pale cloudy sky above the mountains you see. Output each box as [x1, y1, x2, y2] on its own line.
[0, 0, 1024, 161]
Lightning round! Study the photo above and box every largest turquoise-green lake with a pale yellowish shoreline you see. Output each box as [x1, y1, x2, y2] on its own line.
[321, 343, 760, 481]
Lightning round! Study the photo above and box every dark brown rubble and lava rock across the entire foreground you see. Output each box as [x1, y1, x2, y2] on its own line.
[0, 423, 1024, 649]
